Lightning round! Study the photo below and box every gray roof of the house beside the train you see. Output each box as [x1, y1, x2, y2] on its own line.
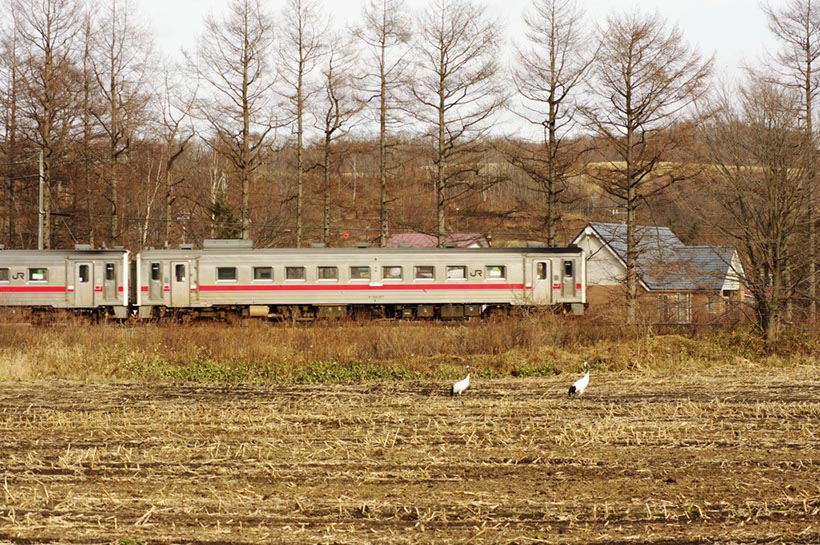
[589, 222, 735, 290]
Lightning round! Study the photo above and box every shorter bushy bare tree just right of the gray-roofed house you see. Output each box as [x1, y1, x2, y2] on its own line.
[693, 76, 810, 348]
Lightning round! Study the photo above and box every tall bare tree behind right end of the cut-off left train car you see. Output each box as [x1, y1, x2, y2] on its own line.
[92, 0, 153, 242]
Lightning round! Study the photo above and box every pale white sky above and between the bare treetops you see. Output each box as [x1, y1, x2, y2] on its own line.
[143, 0, 784, 78]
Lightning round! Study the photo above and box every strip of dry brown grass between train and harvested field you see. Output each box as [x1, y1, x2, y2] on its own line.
[0, 314, 818, 383]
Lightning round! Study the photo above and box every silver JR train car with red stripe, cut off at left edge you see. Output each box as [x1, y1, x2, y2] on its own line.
[0, 245, 131, 319]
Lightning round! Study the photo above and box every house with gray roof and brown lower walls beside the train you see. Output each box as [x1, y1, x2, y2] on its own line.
[573, 222, 743, 323]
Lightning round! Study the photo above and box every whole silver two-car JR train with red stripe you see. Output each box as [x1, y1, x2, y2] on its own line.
[0, 239, 587, 321]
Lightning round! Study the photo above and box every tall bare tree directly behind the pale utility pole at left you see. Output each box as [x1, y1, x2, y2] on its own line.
[10, 0, 83, 248]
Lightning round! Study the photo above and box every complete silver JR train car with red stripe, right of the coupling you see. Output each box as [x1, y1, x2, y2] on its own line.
[132, 240, 586, 320]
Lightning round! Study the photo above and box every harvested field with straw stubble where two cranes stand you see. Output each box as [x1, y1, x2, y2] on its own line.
[0, 367, 820, 545]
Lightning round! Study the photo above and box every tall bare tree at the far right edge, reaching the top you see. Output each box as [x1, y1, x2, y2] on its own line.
[763, 0, 820, 319]
